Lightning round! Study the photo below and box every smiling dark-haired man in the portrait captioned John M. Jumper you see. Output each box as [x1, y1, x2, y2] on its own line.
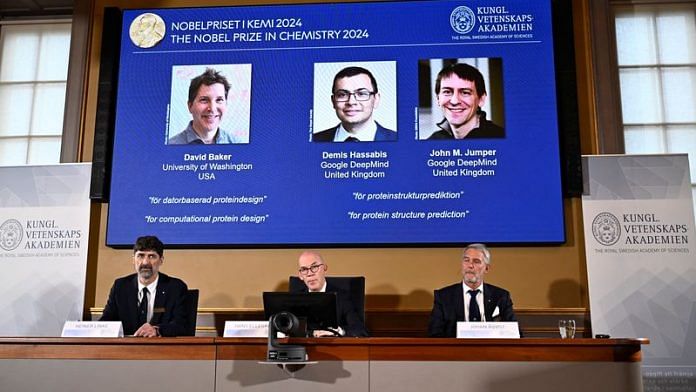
[428, 63, 505, 140]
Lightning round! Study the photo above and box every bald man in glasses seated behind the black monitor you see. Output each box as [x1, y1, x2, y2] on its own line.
[290, 251, 368, 337]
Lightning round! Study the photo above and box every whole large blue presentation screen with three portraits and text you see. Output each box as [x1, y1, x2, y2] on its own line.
[107, 0, 565, 247]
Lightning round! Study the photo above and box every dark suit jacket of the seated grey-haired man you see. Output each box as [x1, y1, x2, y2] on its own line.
[428, 282, 517, 338]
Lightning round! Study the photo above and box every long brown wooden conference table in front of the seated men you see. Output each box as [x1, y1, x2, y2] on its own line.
[0, 337, 649, 392]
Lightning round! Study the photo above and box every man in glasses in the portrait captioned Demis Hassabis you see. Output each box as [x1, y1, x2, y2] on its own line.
[312, 67, 396, 142]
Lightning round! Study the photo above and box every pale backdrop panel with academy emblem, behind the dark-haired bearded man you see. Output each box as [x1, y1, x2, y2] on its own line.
[0, 164, 91, 336]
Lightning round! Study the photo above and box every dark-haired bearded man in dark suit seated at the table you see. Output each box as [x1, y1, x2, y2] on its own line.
[100, 236, 188, 337]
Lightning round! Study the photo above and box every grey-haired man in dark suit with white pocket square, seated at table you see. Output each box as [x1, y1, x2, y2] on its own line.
[428, 244, 517, 338]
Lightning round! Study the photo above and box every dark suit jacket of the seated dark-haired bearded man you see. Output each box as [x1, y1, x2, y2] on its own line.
[100, 272, 188, 336]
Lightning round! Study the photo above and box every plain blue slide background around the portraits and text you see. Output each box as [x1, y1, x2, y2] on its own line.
[107, 0, 565, 247]
